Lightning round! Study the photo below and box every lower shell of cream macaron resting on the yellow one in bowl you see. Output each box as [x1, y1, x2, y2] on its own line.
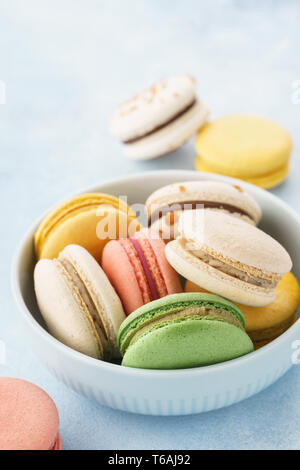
[166, 239, 275, 307]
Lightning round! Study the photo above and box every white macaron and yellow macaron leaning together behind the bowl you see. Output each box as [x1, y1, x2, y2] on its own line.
[110, 75, 292, 188]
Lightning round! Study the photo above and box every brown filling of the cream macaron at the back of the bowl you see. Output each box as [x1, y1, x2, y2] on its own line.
[148, 201, 255, 225]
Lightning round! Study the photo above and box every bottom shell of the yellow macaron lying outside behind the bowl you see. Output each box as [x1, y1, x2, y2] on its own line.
[195, 155, 289, 189]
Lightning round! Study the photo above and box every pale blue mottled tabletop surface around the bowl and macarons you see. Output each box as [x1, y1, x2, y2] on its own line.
[0, 0, 300, 449]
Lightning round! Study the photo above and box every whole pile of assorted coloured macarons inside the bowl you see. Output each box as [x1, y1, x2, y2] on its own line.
[34, 181, 300, 369]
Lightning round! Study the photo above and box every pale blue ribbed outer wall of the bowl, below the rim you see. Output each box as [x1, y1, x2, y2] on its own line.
[21, 321, 300, 416]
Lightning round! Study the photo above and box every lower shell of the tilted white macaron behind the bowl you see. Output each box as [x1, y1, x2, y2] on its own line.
[123, 101, 209, 160]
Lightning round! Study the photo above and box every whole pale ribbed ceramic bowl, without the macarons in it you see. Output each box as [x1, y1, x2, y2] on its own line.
[12, 170, 300, 415]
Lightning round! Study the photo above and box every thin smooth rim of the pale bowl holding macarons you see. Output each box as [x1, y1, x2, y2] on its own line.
[11, 169, 300, 378]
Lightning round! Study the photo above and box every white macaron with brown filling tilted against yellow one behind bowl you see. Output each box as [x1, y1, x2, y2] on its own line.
[110, 75, 209, 160]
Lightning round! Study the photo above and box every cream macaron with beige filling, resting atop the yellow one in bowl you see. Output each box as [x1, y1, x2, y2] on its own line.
[166, 209, 292, 307]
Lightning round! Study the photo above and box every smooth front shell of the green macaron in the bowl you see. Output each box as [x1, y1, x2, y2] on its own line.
[122, 318, 253, 369]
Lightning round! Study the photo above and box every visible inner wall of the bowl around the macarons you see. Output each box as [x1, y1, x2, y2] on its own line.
[13, 170, 300, 354]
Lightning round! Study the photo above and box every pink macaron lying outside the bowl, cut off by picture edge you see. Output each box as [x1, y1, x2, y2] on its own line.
[0, 377, 61, 450]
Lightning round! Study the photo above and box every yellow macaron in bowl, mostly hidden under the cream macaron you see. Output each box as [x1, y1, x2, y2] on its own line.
[184, 273, 300, 349]
